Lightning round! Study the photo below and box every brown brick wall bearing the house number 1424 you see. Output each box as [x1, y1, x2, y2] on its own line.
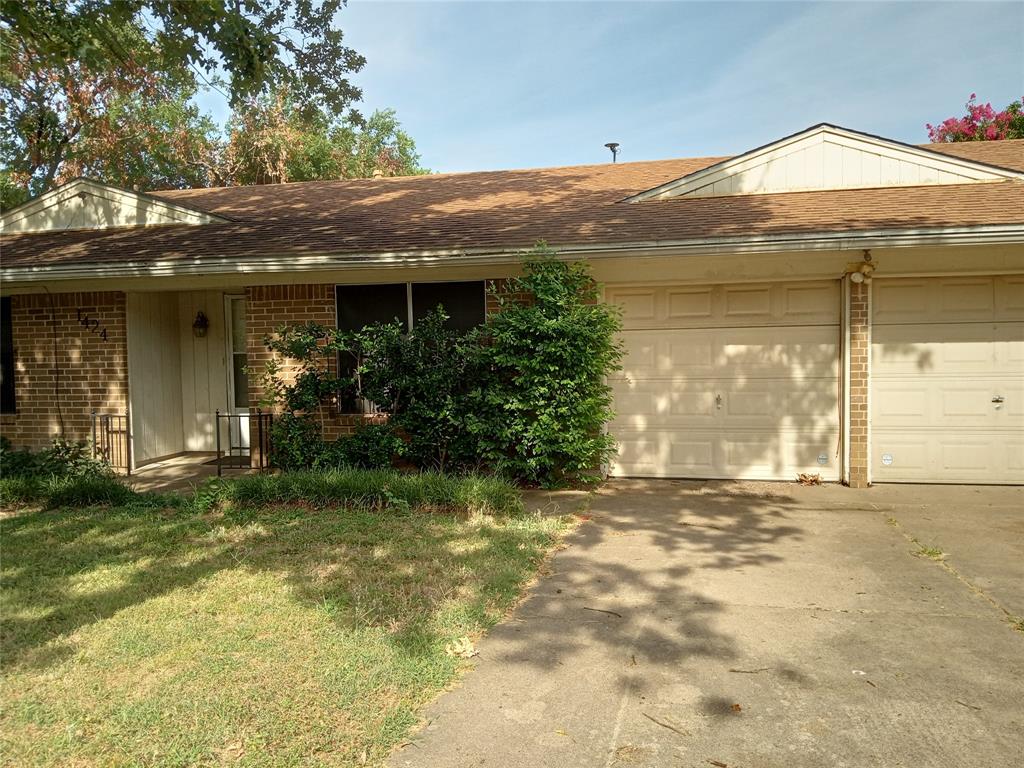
[0, 292, 128, 449]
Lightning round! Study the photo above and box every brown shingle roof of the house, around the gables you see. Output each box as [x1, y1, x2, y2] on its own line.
[2, 140, 1024, 267]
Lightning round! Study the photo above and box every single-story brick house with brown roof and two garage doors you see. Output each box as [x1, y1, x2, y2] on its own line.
[0, 125, 1024, 486]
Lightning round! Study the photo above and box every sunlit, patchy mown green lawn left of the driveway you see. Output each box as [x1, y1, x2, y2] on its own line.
[0, 495, 569, 766]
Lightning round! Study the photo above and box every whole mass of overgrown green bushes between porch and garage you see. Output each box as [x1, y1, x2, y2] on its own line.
[256, 244, 622, 486]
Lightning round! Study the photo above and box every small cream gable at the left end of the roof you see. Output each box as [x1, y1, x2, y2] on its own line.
[0, 178, 224, 234]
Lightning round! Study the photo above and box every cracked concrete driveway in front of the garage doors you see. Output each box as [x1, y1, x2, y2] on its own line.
[391, 481, 1024, 768]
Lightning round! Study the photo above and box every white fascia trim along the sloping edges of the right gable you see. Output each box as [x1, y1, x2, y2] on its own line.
[625, 125, 1024, 203]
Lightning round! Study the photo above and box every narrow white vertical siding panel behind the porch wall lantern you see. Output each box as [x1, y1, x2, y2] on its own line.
[178, 291, 227, 451]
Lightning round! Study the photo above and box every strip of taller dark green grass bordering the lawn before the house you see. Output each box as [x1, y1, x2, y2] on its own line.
[0, 469, 523, 515]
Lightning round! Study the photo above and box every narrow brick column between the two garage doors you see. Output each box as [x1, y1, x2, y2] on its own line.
[847, 276, 871, 488]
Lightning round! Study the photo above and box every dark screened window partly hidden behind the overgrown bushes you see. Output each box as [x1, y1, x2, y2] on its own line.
[335, 281, 486, 413]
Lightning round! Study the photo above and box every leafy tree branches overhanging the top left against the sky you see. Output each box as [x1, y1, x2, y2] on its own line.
[0, 0, 365, 114]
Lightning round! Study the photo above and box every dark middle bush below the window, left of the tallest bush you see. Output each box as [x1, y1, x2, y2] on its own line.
[345, 307, 480, 471]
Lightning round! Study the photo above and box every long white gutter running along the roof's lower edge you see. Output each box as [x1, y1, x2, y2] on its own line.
[0, 224, 1024, 283]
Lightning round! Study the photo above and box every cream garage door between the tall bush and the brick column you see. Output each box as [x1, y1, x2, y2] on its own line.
[605, 281, 840, 480]
